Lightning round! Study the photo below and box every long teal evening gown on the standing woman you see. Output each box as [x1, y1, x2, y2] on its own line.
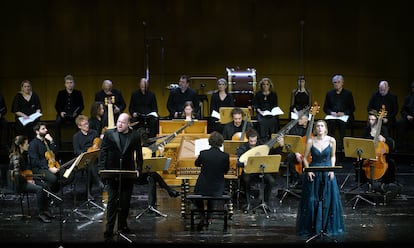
[296, 145, 345, 237]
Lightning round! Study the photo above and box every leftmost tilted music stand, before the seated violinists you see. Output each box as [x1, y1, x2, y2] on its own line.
[67, 150, 105, 221]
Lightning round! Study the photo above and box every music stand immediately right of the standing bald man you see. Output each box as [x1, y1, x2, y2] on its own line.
[135, 157, 171, 219]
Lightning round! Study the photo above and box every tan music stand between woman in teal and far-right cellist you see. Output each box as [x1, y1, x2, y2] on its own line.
[344, 137, 376, 209]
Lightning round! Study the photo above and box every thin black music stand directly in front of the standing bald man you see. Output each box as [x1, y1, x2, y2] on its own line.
[99, 168, 138, 243]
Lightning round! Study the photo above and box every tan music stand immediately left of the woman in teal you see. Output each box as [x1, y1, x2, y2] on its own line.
[279, 135, 305, 204]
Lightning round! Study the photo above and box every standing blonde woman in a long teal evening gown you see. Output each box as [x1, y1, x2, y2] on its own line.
[296, 120, 345, 237]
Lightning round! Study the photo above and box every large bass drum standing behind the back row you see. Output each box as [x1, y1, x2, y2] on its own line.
[226, 68, 256, 107]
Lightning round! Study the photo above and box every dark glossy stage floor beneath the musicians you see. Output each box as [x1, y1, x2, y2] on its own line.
[0, 154, 414, 247]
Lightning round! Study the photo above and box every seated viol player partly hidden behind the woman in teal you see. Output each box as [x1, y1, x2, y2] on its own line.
[286, 114, 309, 186]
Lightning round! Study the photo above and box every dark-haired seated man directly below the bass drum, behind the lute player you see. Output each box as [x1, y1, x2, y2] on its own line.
[223, 107, 253, 140]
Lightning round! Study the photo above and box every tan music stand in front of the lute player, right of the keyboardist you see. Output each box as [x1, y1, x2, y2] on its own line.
[244, 154, 282, 218]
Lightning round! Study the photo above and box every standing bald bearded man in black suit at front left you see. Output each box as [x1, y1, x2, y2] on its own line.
[99, 113, 143, 241]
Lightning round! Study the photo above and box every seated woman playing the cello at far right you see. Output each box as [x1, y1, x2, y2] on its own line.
[360, 110, 395, 184]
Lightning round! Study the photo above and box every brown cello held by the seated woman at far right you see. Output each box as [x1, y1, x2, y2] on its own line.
[362, 105, 389, 180]
